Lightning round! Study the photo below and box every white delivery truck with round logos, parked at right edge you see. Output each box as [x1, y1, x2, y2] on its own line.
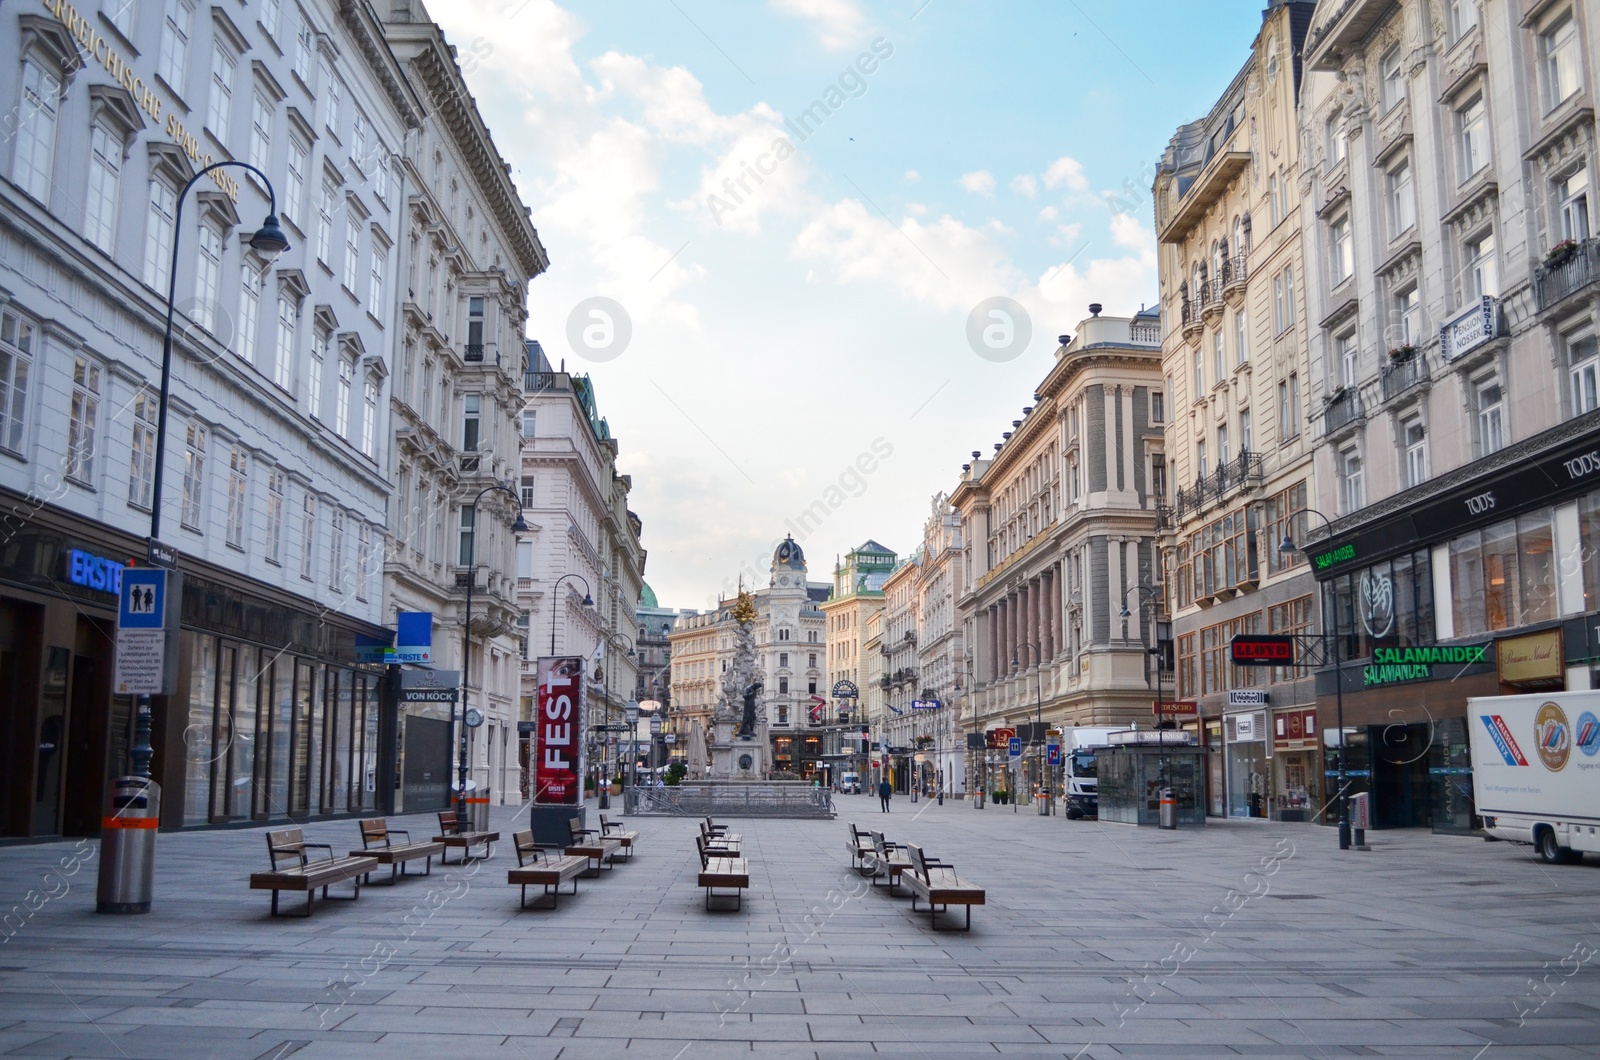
[1467, 692, 1600, 865]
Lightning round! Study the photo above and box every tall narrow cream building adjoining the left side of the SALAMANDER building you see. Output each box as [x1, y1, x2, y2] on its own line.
[1158, 0, 1318, 820]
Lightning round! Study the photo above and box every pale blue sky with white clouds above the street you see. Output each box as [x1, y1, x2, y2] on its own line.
[430, 0, 1262, 607]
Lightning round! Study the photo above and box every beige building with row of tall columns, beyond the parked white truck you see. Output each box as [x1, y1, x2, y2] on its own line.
[950, 304, 1166, 807]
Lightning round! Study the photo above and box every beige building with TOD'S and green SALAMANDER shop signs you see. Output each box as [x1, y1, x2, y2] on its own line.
[1294, 0, 1600, 831]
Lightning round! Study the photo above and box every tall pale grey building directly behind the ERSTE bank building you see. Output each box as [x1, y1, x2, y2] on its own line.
[380, 0, 549, 809]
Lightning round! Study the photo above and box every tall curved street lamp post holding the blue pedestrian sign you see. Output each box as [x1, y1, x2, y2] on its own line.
[99, 162, 290, 913]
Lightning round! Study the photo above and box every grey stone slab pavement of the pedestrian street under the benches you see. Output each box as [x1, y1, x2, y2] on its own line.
[0, 807, 1600, 1060]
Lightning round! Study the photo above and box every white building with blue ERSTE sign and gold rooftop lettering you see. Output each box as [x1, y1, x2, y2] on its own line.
[0, 0, 422, 834]
